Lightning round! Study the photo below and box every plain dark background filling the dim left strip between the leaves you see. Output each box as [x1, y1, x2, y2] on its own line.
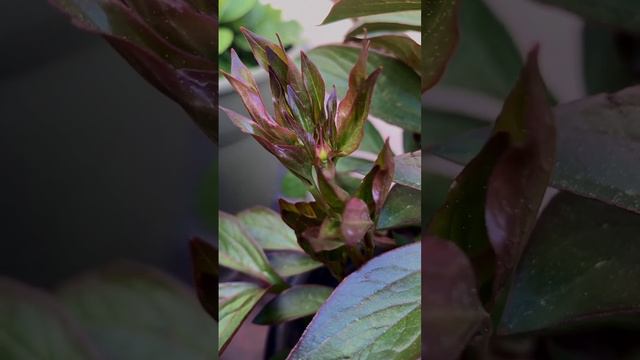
[0, 0, 216, 286]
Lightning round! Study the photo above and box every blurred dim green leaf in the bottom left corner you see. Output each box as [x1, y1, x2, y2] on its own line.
[0, 277, 101, 360]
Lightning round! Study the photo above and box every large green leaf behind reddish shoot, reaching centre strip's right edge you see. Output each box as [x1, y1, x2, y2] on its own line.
[309, 45, 422, 133]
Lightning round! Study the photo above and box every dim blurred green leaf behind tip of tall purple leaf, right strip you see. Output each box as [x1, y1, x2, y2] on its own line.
[440, 0, 522, 100]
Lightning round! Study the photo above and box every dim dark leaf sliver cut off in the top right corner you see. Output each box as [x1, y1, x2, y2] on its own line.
[537, 0, 640, 34]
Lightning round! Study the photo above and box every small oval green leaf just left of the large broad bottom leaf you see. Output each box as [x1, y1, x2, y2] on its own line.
[253, 285, 333, 325]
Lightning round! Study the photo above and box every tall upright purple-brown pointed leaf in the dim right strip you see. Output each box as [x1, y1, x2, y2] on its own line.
[485, 49, 556, 300]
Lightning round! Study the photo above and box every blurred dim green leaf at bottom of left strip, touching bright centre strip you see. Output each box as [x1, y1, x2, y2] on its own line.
[58, 264, 216, 360]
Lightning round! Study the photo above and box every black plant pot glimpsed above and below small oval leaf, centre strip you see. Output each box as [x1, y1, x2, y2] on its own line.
[265, 267, 338, 360]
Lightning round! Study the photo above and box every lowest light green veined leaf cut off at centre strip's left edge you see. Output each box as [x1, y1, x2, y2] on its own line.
[218, 282, 267, 354]
